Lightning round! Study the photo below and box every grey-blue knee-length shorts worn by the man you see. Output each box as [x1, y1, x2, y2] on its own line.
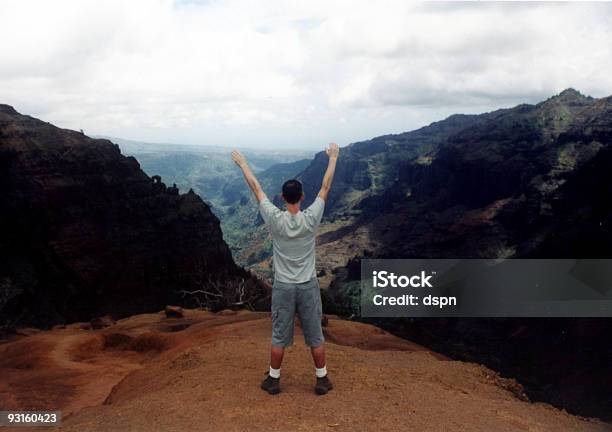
[272, 277, 325, 347]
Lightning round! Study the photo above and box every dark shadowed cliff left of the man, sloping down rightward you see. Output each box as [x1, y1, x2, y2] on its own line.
[0, 105, 253, 325]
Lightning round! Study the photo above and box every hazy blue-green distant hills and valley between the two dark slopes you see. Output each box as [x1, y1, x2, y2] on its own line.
[108, 137, 314, 264]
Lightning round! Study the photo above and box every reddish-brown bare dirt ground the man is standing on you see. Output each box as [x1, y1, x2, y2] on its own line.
[0, 311, 610, 432]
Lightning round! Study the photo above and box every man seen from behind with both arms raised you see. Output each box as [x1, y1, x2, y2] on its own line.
[232, 143, 340, 395]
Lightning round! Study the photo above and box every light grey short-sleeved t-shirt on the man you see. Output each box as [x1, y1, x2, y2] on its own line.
[259, 197, 325, 283]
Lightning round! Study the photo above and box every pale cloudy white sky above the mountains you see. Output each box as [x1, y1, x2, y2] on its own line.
[0, 0, 612, 149]
